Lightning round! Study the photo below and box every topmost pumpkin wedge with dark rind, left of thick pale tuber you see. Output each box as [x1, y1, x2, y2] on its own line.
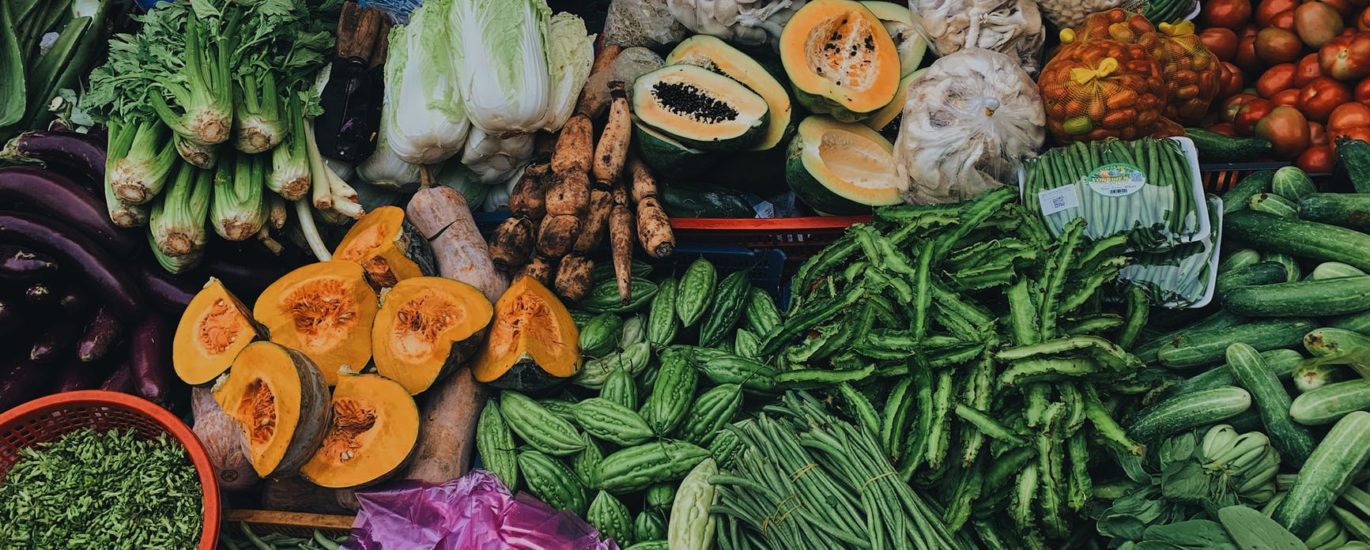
[333, 206, 437, 288]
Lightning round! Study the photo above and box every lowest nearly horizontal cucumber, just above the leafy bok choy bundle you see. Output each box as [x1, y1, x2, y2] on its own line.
[1128, 385, 1251, 443]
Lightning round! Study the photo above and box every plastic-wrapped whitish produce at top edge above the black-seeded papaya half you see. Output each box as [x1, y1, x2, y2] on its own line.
[666, 0, 808, 45]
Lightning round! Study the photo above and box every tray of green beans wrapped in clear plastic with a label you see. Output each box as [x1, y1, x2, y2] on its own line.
[1019, 137, 1211, 250]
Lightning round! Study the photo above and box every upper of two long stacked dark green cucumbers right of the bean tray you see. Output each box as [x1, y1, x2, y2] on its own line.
[1222, 210, 1370, 270]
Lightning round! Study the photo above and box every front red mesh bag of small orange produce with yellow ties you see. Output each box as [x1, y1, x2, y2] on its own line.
[1037, 40, 1184, 143]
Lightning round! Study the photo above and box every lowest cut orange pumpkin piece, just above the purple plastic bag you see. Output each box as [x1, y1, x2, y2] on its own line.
[300, 373, 419, 488]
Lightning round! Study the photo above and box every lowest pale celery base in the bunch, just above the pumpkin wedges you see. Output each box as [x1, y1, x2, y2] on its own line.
[148, 165, 214, 258]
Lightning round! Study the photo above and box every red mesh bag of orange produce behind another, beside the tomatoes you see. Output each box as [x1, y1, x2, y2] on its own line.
[1060, 8, 1222, 123]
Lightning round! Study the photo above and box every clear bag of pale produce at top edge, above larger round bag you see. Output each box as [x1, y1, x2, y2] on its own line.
[908, 0, 1047, 74]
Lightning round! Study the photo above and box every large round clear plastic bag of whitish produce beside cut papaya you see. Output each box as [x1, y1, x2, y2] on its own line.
[895, 49, 1047, 204]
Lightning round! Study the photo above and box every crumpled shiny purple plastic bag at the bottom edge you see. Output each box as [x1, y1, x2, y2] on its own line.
[343, 470, 618, 550]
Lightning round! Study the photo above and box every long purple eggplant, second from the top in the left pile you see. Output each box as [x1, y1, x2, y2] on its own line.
[0, 166, 141, 255]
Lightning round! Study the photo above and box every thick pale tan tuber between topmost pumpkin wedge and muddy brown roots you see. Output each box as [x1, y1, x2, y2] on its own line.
[404, 187, 510, 303]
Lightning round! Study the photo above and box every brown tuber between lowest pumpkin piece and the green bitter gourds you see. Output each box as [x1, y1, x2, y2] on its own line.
[404, 368, 485, 483]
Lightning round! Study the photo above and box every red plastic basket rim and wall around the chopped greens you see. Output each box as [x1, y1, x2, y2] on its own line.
[0, 390, 219, 550]
